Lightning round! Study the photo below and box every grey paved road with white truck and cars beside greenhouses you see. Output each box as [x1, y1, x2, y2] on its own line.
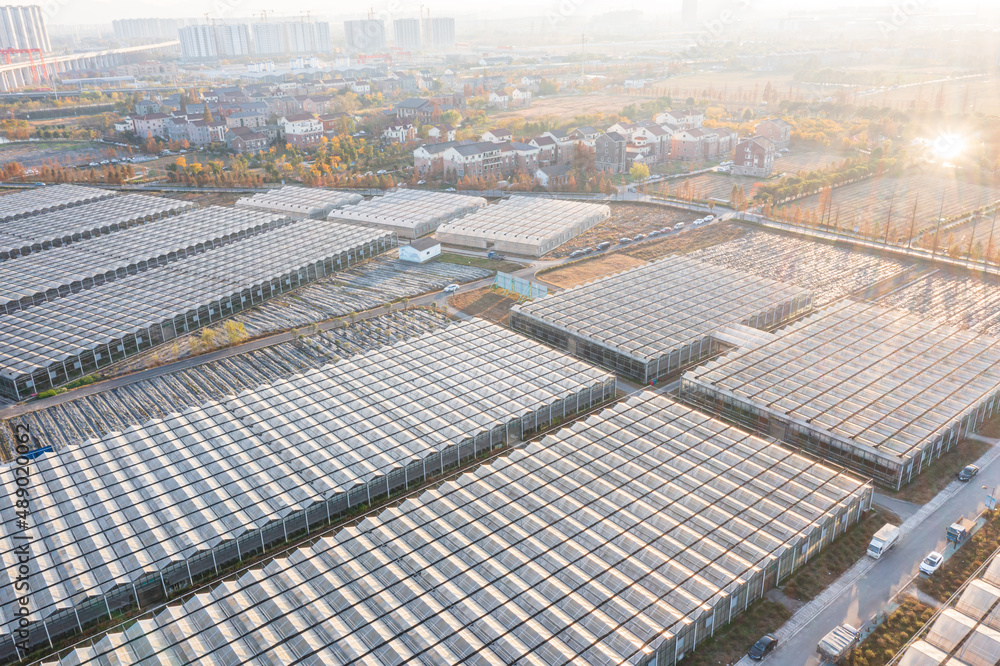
[752, 440, 1000, 666]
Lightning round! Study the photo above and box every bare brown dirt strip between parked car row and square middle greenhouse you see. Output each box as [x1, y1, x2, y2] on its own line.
[537, 223, 746, 289]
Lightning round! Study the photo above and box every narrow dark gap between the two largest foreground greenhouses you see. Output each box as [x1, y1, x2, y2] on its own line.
[19, 387, 628, 666]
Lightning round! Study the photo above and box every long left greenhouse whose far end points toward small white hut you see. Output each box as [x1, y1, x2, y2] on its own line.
[0, 216, 396, 400]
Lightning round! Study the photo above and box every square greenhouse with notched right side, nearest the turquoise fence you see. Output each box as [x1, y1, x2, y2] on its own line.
[508, 253, 812, 384]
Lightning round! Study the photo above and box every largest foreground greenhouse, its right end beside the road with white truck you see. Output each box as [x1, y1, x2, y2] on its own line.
[37, 392, 872, 666]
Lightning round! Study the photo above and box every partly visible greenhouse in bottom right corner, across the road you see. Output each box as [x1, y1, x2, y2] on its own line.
[890, 557, 1000, 666]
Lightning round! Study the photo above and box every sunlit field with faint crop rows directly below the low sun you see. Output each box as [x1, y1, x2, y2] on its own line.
[782, 173, 1000, 240]
